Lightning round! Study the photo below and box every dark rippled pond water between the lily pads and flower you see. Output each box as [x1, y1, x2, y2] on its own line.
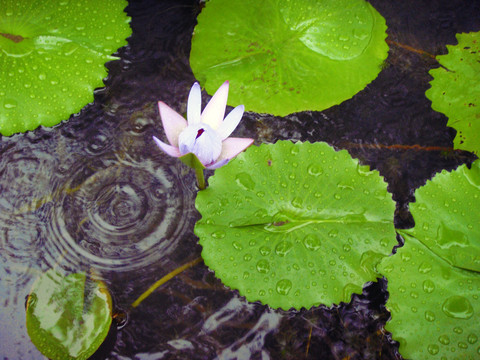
[0, 0, 480, 360]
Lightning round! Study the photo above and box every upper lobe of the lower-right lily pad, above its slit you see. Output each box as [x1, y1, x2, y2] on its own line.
[399, 160, 480, 272]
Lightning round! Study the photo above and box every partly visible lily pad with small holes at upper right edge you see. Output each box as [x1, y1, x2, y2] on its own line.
[426, 32, 480, 154]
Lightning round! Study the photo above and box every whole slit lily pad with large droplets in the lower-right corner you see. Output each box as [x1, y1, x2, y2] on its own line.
[379, 160, 480, 359]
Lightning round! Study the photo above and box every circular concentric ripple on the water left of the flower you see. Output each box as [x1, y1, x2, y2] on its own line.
[45, 161, 193, 271]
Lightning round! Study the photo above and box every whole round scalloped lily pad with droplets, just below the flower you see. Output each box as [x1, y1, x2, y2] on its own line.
[195, 141, 396, 309]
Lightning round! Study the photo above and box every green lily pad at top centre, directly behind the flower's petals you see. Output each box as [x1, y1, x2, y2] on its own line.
[190, 0, 388, 116]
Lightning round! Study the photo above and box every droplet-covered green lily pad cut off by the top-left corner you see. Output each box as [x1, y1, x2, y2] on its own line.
[0, 0, 131, 136]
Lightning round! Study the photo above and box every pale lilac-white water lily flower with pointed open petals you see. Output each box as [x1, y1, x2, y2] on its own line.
[153, 81, 254, 172]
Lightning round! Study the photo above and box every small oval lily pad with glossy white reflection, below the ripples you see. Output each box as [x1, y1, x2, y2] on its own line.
[26, 270, 112, 360]
